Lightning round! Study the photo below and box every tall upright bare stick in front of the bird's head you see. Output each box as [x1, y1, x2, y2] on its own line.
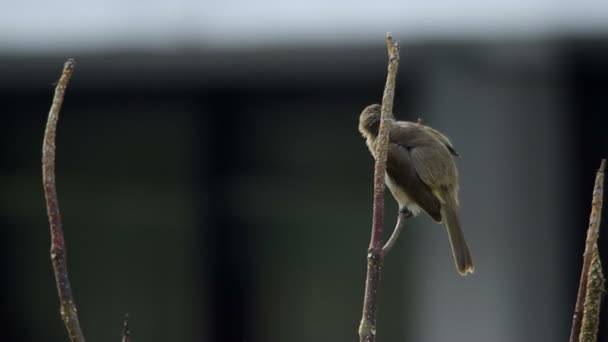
[359, 33, 399, 342]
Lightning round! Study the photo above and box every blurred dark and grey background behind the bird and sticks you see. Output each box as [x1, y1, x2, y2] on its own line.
[0, 0, 608, 342]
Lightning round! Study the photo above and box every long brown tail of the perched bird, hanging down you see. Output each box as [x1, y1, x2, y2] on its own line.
[441, 193, 475, 276]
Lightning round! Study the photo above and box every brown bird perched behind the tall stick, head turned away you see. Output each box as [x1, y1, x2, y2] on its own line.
[359, 104, 475, 275]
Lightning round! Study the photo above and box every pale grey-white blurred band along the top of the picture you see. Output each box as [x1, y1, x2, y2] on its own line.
[0, 0, 608, 54]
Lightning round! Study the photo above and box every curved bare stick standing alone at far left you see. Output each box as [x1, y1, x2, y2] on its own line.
[42, 59, 85, 342]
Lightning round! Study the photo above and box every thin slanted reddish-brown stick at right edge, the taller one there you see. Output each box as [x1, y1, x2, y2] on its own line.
[570, 159, 606, 342]
